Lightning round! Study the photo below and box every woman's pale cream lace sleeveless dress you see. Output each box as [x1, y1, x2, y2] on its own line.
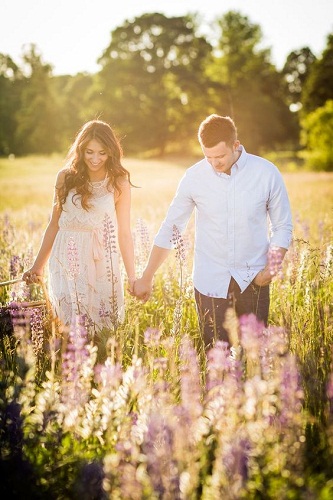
[49, 182, 124, 330]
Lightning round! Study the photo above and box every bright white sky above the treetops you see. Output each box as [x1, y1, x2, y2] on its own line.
[0, 0, 333, 75]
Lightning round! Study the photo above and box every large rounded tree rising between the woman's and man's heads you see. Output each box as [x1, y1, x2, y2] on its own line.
[99, 13, 211, 154]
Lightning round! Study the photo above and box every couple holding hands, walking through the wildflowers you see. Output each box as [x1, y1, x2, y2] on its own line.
[23, 114, 292, 348]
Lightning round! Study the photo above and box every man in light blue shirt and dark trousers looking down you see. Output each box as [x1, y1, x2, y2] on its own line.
[134, 114, 292, 349]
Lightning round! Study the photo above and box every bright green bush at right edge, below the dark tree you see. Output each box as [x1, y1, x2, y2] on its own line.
[301, 100, 333, 171]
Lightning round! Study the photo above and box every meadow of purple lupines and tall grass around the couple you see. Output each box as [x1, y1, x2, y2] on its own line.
[0, 158, 333, 500]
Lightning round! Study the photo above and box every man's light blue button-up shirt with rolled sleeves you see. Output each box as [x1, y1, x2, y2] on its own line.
[154, 146, 292, 298]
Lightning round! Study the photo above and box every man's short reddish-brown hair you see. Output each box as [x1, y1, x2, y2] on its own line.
[198, 114, 237, 148]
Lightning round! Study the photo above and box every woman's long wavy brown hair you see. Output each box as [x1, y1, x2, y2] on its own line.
[58, 120, 131, 210]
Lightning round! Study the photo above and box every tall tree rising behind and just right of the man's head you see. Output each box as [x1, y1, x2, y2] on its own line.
[210, 11, 295, 152]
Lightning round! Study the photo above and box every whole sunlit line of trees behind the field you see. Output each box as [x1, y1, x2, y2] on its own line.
[0, 11, 333, 170]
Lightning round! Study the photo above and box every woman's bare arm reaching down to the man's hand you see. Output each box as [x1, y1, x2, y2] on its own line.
[116, 180, 135, 291]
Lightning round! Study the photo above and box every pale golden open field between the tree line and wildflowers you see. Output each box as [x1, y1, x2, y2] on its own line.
[0, 156, 333, 244]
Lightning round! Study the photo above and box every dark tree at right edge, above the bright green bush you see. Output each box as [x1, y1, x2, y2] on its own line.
[302, 33, 333, 116]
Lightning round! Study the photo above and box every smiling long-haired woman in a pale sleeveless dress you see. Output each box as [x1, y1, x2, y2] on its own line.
[23, 120, 135, 329]
